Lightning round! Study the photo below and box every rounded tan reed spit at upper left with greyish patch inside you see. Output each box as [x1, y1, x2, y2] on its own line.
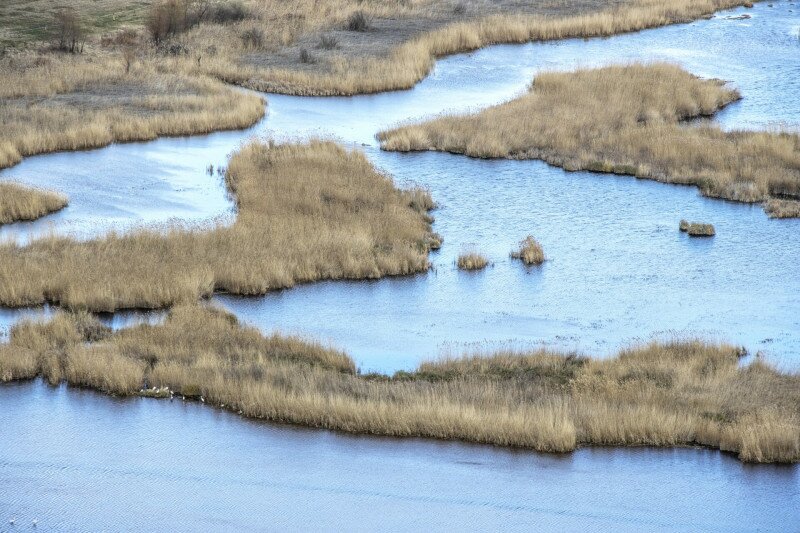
[0, 60, 265, 168]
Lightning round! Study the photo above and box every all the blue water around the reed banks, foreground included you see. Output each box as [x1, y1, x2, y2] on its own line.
[0, 2, 800, 531]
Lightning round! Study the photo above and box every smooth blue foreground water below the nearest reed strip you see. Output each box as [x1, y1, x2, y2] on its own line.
[0, 381, 800, 531]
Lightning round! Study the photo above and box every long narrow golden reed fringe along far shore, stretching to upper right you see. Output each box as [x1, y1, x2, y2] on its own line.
[194, 0, 749, 96]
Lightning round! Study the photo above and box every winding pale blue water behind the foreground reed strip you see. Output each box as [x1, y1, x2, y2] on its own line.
[0, 2, 800, 371]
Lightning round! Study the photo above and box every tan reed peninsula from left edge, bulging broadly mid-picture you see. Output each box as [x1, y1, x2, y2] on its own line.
[0, 142, 434, 311]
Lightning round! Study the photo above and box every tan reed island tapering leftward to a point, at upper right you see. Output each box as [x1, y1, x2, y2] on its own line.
[379, 64, 800, 216]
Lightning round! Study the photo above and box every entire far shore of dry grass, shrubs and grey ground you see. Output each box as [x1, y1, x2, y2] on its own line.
[0, 0, 746, 168]
